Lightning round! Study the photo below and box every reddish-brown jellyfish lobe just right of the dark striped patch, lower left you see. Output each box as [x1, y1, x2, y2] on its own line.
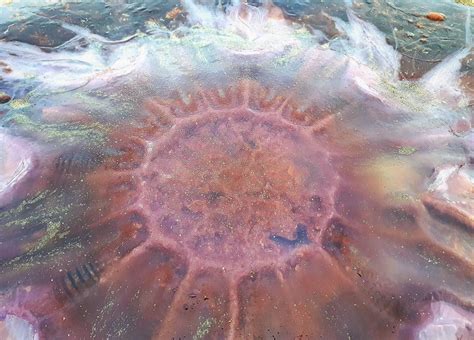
[41, 247, 187, 338]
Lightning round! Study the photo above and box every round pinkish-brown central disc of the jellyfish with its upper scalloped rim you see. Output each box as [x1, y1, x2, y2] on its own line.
[133, 83, 337, 269]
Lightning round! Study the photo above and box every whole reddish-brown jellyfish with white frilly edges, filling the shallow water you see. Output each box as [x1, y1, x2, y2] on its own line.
[0, 1, 474, 339]
